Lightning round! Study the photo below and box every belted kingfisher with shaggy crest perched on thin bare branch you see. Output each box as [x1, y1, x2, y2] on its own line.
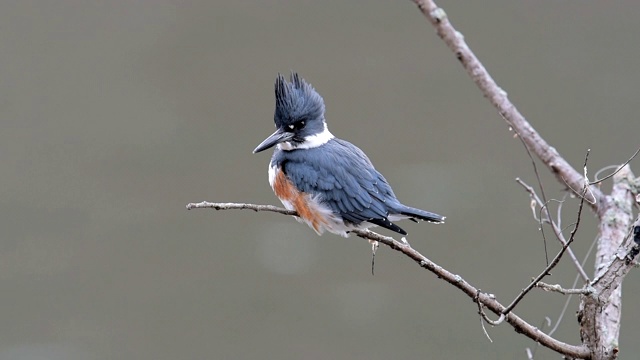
[253, 72, 445, 237]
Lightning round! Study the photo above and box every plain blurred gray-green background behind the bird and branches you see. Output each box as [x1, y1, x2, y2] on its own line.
[0, 0, 640, 360]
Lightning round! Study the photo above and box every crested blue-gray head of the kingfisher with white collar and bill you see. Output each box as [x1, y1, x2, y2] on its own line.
[253, 72, 333, 153]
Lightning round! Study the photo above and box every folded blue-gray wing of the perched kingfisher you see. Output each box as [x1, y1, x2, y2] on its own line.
[274, 139, 405, 233]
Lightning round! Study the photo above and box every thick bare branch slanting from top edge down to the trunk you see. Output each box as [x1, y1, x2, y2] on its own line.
[413, 0, 603, 211]
